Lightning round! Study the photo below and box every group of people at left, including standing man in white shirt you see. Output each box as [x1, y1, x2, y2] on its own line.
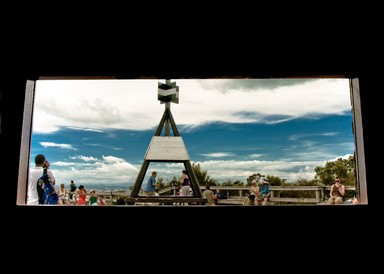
[27, 154, 106, 205]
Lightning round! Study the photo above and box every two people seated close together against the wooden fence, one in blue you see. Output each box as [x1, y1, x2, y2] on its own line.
[243, 178, 271, 205]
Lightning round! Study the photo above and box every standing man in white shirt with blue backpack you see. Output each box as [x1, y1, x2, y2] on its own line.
[27, 154, 58, 205]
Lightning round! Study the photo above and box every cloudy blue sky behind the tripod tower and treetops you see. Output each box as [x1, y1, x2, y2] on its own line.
[30, 79, 354, 186]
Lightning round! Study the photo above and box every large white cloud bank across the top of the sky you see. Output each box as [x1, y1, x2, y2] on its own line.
[33, 79, 351, 133]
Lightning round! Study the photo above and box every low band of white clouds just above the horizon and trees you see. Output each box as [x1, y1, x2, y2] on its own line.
[51, 155, 336, 187]
